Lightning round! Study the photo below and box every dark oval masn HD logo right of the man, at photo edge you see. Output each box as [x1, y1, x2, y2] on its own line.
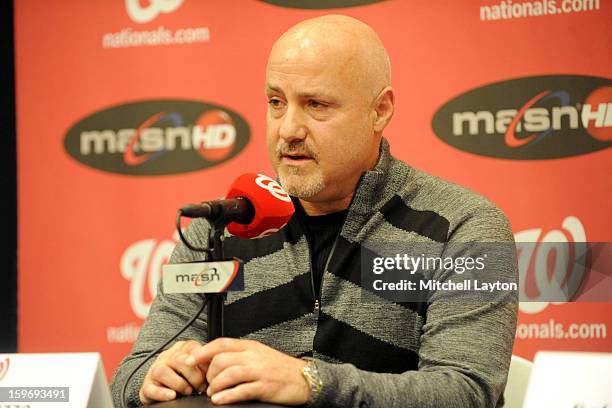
[432, 75, 612, 160]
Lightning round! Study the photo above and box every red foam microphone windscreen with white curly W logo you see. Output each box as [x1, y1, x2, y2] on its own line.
[226, 173, 295, 238]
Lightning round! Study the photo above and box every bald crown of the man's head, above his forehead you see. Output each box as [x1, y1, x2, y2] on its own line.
[268, 15, 391, 100]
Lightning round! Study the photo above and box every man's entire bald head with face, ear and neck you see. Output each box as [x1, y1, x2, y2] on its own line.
[266, 15, 394, 215]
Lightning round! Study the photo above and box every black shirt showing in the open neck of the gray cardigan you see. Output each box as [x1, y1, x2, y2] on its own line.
[294, 200, 348, 299]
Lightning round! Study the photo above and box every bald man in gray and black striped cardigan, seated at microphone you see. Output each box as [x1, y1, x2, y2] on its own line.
[113, 16, 517, 408]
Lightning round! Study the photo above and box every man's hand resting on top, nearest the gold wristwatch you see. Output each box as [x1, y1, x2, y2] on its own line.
[192, 338, 310, 405]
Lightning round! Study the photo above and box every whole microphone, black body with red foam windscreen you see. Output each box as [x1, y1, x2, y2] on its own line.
[181, 173, 295, 238]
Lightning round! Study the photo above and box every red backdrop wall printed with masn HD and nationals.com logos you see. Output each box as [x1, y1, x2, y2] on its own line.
[15, 0, 612, 375]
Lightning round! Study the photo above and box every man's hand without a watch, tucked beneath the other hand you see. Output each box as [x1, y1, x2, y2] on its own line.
[139, 340, 206, 404]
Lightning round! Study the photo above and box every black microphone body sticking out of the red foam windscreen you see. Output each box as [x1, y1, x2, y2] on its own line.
[180, 197, 255, 225]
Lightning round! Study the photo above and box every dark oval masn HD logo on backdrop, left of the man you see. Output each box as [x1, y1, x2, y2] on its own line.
[64, 100, 250, 176]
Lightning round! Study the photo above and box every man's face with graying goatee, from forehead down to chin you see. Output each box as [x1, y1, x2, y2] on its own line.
[266, 43, 378, 201]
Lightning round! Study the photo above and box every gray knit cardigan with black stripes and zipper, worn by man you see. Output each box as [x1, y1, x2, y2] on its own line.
[112, 139, 517, 408]
